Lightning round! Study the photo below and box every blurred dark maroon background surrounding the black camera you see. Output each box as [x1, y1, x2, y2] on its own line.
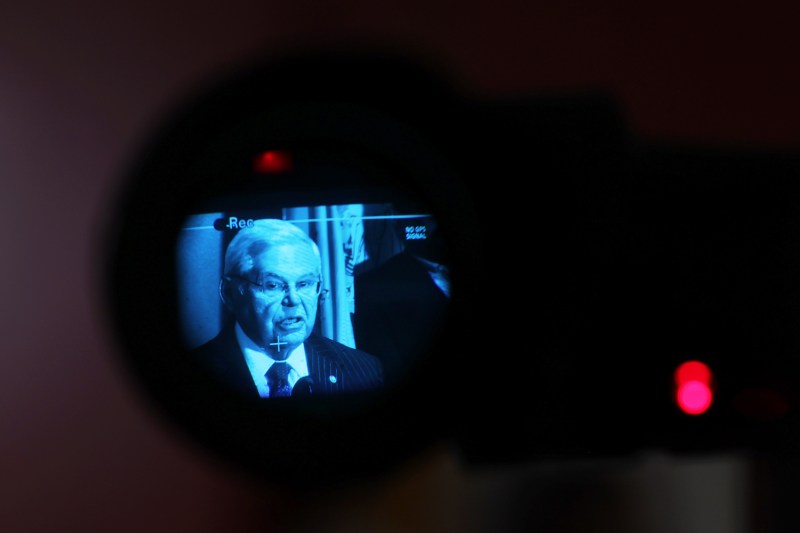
[0, 0, 800, 532]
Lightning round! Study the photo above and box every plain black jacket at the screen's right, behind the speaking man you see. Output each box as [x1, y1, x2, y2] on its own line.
[353, 252, 449, 383]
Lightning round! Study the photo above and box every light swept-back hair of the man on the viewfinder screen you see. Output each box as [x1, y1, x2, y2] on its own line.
[224, 218, 321, 276]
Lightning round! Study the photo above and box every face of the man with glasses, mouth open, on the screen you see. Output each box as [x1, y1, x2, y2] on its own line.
[231, 243, 320, 358]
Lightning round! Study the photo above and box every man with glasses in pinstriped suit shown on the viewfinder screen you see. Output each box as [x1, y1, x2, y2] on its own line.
[194, 219, 383, 398]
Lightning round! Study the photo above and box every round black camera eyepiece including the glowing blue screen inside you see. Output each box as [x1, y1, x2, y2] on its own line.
[102, 52, 476, 487]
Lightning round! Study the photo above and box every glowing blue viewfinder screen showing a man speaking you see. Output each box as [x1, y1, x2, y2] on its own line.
[176, 202, 454, 399]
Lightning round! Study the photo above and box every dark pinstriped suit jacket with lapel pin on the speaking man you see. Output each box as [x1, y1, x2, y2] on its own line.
[193, 323, 383, 398]
